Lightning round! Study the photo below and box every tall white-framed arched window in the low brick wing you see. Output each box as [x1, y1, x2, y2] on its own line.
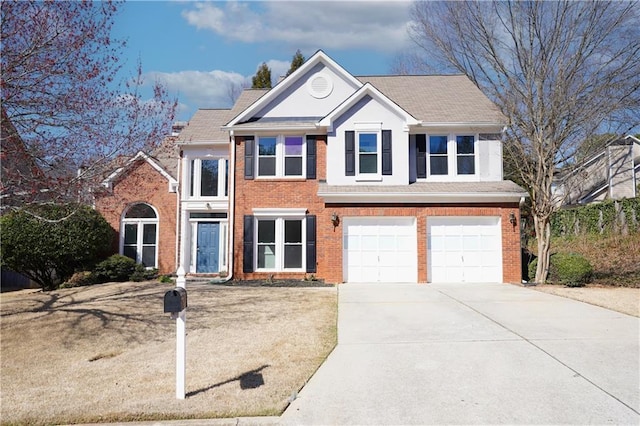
[120, 203, 158, 268]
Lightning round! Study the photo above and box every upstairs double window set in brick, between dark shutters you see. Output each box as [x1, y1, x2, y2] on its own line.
[257, 135, 305, 177]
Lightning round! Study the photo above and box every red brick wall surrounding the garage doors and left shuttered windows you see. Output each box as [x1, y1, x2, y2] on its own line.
[233, 137, 521, 283]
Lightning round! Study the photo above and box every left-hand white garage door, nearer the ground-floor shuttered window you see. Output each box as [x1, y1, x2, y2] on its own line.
[342, 218, 418, 282]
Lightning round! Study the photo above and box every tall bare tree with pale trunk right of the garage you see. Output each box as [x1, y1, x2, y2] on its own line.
[410, 1, 640, 282]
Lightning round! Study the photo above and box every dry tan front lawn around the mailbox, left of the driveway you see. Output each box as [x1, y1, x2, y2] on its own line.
[0, 282, 337, 424]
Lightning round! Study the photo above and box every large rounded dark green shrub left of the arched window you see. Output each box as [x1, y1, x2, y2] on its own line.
[0, 204, 113, 291]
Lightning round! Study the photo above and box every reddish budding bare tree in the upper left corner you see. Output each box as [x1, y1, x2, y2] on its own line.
[0, 1, 176, 210]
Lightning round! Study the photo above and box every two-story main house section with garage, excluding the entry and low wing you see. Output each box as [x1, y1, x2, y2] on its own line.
[223, 51, 526, 283]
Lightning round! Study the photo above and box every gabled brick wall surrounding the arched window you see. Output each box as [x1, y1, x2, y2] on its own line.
[95, 160, 177, 274]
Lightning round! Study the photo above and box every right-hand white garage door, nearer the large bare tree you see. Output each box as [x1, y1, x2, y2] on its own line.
[427, 217, 502, 282]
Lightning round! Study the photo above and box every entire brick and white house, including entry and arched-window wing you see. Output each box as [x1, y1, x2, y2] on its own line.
[96, 51, 526, 283]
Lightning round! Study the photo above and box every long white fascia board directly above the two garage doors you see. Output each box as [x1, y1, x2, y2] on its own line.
[318, 192, 529, 204]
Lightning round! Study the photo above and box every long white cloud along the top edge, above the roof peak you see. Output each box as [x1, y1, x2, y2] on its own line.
[182, 1, 410, 52]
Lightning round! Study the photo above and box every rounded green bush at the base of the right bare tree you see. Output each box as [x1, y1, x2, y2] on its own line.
[529, 253, 593, 287]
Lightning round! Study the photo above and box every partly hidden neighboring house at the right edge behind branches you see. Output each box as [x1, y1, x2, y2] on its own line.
[554, 135, 640, 206]
